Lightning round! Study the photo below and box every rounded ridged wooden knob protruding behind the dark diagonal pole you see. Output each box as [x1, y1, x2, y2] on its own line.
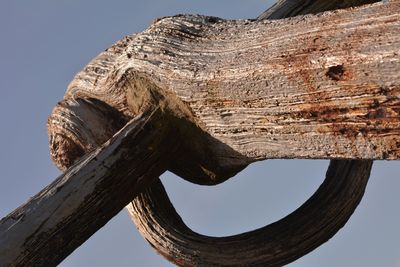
[47, 98, 126, 170]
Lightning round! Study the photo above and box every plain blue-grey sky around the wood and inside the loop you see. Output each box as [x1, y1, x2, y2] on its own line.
[0, 0, 400, 267]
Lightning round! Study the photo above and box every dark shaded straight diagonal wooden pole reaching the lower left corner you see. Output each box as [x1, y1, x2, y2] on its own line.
[0, 109, 179, 266]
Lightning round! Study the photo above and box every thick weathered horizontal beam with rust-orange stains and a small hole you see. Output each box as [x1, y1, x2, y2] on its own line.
[54, 0, 400, 183]
